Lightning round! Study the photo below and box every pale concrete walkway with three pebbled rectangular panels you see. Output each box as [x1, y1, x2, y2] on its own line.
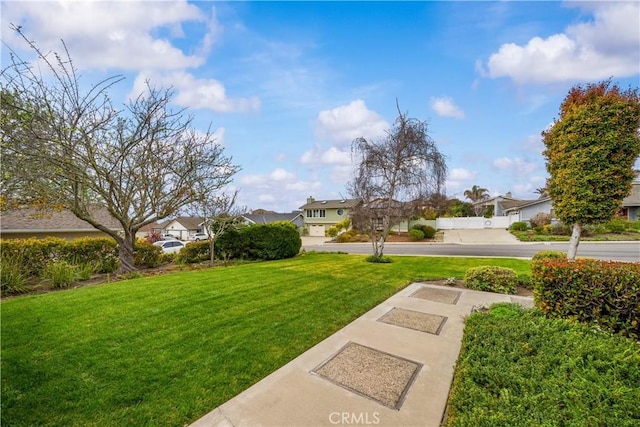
[192, 283, 533, 427]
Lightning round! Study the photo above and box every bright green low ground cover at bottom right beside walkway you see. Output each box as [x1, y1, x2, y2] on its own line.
[446, 304, 640, 427]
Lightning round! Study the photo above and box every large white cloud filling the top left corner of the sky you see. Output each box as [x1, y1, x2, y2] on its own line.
[2, 0, 220, 70]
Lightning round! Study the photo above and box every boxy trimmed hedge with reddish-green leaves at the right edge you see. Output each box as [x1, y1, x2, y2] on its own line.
[531, 259, 640, 339]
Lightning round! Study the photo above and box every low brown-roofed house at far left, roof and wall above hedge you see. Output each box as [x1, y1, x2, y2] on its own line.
[0, 207, 123, 240]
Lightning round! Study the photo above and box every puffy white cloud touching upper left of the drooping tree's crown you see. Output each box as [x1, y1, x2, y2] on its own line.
[316, 99, 389, 144]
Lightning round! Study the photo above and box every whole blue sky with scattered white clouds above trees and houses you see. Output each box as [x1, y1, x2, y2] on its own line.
[1, 1, 640, 212]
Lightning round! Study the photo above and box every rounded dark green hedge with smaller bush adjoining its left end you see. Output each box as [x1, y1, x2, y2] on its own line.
[176, 222, 302, 263]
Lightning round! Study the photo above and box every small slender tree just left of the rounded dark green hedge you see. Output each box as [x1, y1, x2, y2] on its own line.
[191, 190, 246, 263]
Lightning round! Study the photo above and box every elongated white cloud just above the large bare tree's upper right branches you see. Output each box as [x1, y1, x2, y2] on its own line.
[129, 71, 260, 113]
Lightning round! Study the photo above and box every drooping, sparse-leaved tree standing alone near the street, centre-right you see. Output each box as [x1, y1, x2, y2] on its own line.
[349, 103, 447, 259]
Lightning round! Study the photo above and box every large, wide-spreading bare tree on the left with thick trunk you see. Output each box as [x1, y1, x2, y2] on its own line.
[0, 27, 239, 273]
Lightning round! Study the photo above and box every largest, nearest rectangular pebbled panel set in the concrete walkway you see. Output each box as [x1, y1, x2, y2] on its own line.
[313, 342, 422, 409]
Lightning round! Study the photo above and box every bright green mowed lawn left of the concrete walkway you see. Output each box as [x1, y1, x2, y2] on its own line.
[1, 254, 529, 426]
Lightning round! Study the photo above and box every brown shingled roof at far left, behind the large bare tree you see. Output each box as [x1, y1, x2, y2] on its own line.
[0, 207, 122, 233]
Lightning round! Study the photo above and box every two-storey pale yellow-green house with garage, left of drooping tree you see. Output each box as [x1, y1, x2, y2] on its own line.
[300, 197, 360, 237]
